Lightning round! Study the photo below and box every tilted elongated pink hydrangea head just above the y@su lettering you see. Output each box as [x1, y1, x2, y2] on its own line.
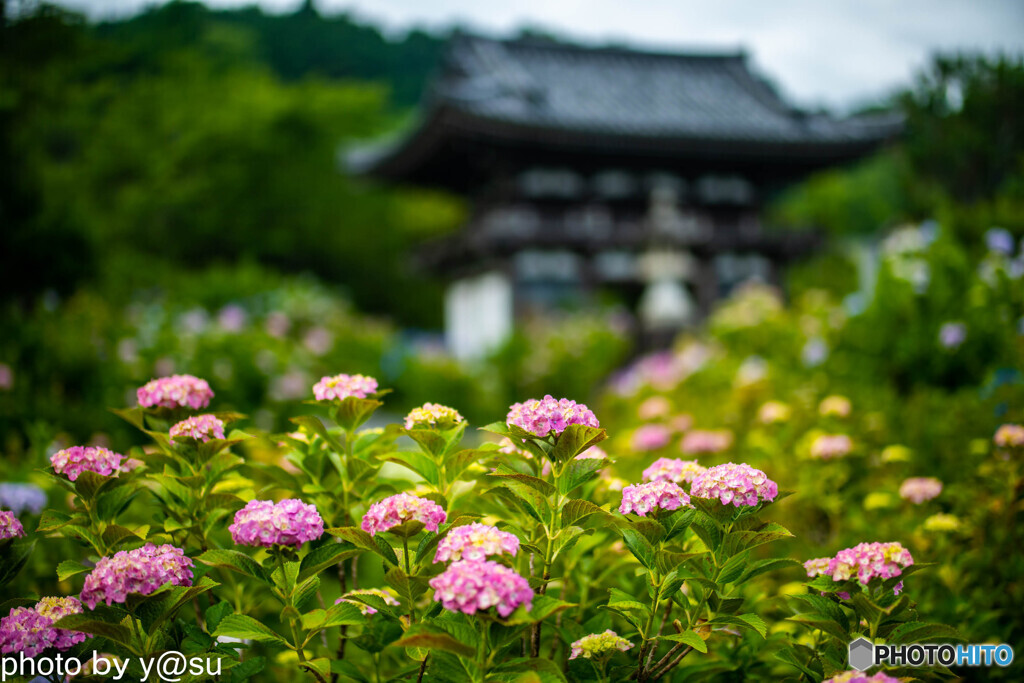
[80, 543, 193, 609]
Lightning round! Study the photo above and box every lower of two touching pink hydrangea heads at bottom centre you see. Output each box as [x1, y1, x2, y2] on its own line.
[430, 560, 534, 616]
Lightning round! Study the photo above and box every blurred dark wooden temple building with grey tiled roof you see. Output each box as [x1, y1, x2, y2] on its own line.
[347, 35, 900, 358]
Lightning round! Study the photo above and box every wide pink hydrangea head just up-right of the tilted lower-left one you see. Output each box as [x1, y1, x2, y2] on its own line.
[227, 498, 324, 548]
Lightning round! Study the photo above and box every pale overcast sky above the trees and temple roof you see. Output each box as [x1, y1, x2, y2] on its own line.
[54, 0, 1024, 109]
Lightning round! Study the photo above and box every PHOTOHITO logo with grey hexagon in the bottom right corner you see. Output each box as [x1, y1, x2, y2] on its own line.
[850, 638, 1014, 671]
